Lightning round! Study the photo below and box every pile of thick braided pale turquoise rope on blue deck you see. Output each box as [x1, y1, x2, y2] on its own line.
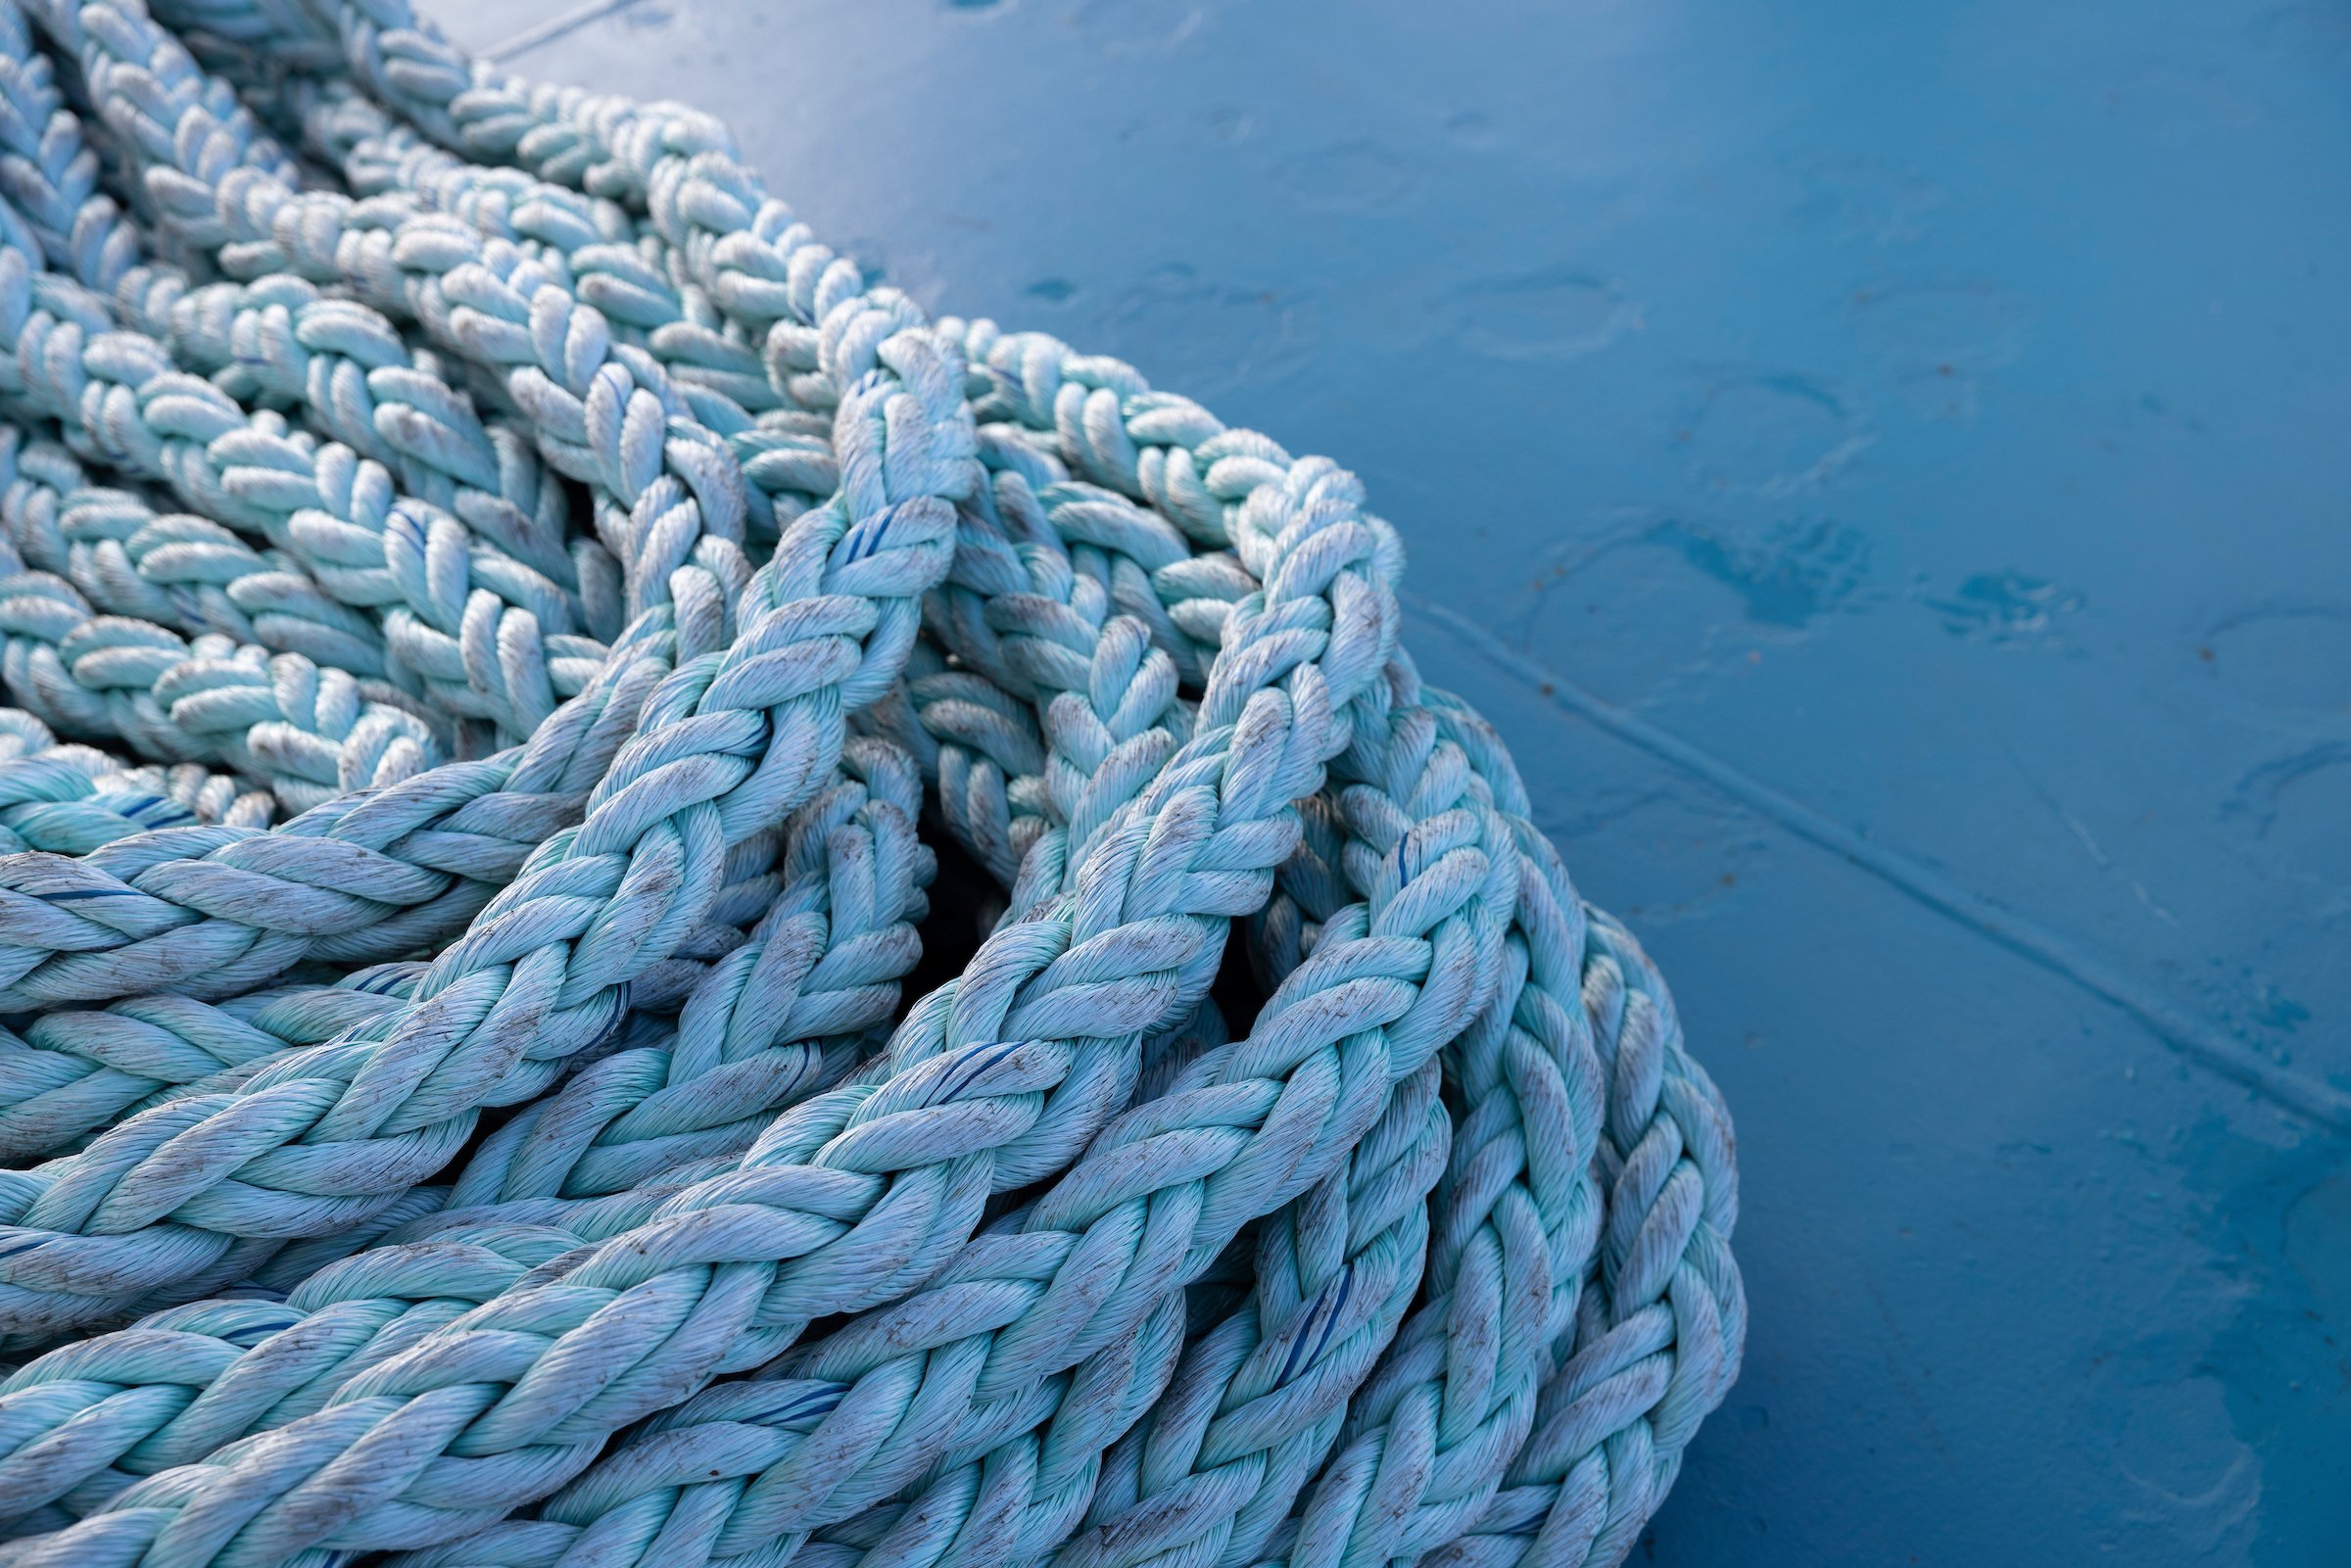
[0, 0, 1745, 1568]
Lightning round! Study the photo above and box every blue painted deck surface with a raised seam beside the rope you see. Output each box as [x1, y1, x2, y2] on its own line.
[433, 0, 2351, 1568]
